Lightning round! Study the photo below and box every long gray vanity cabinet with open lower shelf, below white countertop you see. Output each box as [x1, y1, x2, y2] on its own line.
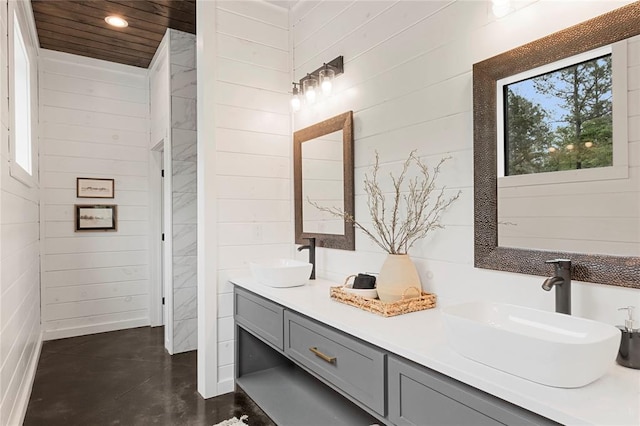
[234, 287, 557, 426]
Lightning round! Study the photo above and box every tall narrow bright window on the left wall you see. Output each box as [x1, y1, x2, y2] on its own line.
[9, 9, 33, 184]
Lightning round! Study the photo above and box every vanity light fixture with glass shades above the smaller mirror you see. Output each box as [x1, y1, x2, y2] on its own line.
[291, 56, 344, 111]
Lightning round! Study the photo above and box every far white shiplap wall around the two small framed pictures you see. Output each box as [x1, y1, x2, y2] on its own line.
[40, 50, 149, 339]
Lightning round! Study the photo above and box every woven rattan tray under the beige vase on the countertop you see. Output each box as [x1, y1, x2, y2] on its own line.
[329, 286, 436, 317]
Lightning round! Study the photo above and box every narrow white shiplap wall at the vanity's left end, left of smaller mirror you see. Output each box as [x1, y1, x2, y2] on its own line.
[209, 1, 293, 393]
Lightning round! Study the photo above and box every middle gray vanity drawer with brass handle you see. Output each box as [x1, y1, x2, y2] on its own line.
[284, 311, 385, 416]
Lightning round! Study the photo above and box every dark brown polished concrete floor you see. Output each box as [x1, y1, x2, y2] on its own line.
[24, 327, 274, 426]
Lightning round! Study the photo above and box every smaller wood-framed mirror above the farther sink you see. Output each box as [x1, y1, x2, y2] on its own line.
[293, 111, 355, 250]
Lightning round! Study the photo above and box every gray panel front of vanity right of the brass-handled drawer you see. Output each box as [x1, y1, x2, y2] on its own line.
[388, 357, 557, 426]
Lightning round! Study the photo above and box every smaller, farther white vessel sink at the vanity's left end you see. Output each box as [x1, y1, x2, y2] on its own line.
[249, 259, 313, 287]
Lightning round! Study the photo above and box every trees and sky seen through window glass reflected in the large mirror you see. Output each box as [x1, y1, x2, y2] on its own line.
[504, 55, 613, 175]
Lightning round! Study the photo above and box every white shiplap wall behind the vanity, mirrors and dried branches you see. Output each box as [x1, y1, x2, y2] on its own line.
[291, 0, 640, 324]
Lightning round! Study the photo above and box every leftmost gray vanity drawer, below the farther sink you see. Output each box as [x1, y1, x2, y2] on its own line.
[233, 287, 284, 350]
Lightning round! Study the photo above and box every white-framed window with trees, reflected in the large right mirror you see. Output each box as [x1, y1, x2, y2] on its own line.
[496, 41, 629, 187]
